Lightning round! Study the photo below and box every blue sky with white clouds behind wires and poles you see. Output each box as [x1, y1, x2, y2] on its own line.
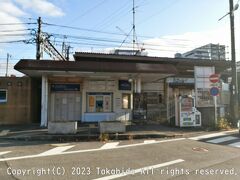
[0, 0, 240, 76]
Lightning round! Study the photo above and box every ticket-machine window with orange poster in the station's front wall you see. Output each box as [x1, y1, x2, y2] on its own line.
[87, 93, 112, 112]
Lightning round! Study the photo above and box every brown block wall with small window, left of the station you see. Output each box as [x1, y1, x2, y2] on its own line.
[0, 77, 31, 124]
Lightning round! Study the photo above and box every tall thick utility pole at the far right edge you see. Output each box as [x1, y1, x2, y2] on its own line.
[229, 0, 239, 123]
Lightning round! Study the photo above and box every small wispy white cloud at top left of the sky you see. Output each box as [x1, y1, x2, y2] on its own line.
[15, 0, 64, 17]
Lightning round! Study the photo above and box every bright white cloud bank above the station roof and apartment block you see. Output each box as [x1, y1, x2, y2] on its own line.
[144, 26, 230, 57]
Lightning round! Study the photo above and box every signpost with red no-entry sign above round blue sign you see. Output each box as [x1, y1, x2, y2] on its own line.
[209, 74, 220, 125]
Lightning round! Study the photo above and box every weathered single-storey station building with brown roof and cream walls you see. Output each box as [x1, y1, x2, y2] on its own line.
[8, 52, 230, 126]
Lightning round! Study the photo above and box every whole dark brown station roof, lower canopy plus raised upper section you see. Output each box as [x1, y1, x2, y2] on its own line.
[14, 53, 230, 76]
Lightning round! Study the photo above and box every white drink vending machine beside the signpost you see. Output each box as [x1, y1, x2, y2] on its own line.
[177, 96, 202, 127]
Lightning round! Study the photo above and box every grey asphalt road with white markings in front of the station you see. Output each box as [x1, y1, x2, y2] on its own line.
[0, 134, 240, 180]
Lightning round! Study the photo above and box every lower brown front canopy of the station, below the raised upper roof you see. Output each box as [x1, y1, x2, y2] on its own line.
[14, 60, 177, 76]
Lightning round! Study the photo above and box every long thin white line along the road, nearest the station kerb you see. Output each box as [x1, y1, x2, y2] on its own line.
[0, 138, 186, 162]
